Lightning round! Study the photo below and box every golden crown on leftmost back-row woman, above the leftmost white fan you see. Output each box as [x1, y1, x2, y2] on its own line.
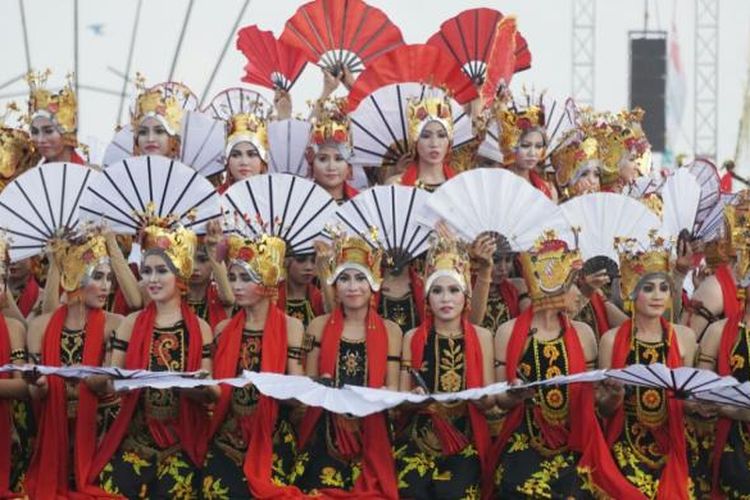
[26, 70, 78, 147]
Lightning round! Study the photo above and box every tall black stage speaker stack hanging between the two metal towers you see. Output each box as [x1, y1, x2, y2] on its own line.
[630, 31, 667, 152]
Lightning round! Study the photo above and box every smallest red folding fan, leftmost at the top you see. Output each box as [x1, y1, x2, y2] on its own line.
[237, 25, 307, 92]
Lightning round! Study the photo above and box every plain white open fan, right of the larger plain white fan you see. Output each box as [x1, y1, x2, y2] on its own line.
[560, 193, 661, 262]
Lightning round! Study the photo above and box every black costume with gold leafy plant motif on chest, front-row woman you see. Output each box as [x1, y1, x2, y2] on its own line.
[395, 331, 481, 499]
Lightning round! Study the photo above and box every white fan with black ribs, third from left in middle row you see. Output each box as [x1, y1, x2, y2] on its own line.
[222, 174, 336, 254]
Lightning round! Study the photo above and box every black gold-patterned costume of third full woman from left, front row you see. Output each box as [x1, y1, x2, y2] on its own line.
[202, 330, 296, 499]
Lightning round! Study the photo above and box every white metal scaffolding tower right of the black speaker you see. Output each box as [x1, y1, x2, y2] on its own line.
[693, 0, 719, 161]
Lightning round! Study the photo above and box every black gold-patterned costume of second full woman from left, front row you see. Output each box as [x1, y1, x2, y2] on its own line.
[99, 321, 200, 498]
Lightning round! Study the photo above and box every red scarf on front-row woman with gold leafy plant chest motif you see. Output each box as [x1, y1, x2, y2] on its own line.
[410, 318, 494, 498]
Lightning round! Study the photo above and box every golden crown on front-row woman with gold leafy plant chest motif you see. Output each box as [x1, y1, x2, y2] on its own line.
[424, 237, 471, 296]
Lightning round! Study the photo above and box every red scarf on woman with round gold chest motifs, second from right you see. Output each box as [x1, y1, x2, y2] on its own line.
[605, 318, 689, 500]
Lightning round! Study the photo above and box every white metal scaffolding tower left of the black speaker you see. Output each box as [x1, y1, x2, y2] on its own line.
[571, 0, 596, 106]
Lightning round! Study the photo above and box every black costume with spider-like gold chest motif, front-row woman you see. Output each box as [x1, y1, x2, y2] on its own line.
[290, 337, 367, 492]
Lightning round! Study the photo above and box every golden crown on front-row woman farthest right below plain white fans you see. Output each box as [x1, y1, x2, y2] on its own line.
[614, 230, 672, 308]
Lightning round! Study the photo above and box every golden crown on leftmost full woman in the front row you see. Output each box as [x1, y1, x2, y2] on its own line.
[52, 232, 109, 292]
